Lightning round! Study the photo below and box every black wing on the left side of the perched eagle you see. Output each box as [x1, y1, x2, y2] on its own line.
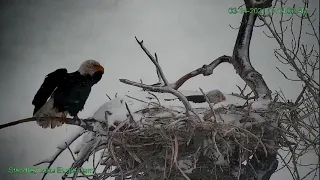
[32, 68, 68, 115]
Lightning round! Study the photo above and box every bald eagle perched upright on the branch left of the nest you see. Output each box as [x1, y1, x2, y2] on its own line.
[32, 60, 104, 129]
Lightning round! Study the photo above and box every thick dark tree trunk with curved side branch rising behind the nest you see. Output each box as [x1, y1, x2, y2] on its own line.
[150, 0, 272, 99]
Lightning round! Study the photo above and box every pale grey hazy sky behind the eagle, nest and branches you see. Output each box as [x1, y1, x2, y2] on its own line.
[0, 0, 319, 180]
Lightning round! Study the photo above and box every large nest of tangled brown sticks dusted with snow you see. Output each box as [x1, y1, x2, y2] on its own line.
[103, 97, 277, 179]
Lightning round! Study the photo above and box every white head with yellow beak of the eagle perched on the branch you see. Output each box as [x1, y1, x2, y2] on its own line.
[78, 59, 104, 76]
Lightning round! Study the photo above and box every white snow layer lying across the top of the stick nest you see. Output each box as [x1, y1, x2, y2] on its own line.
[93, 91, 246, 127]
